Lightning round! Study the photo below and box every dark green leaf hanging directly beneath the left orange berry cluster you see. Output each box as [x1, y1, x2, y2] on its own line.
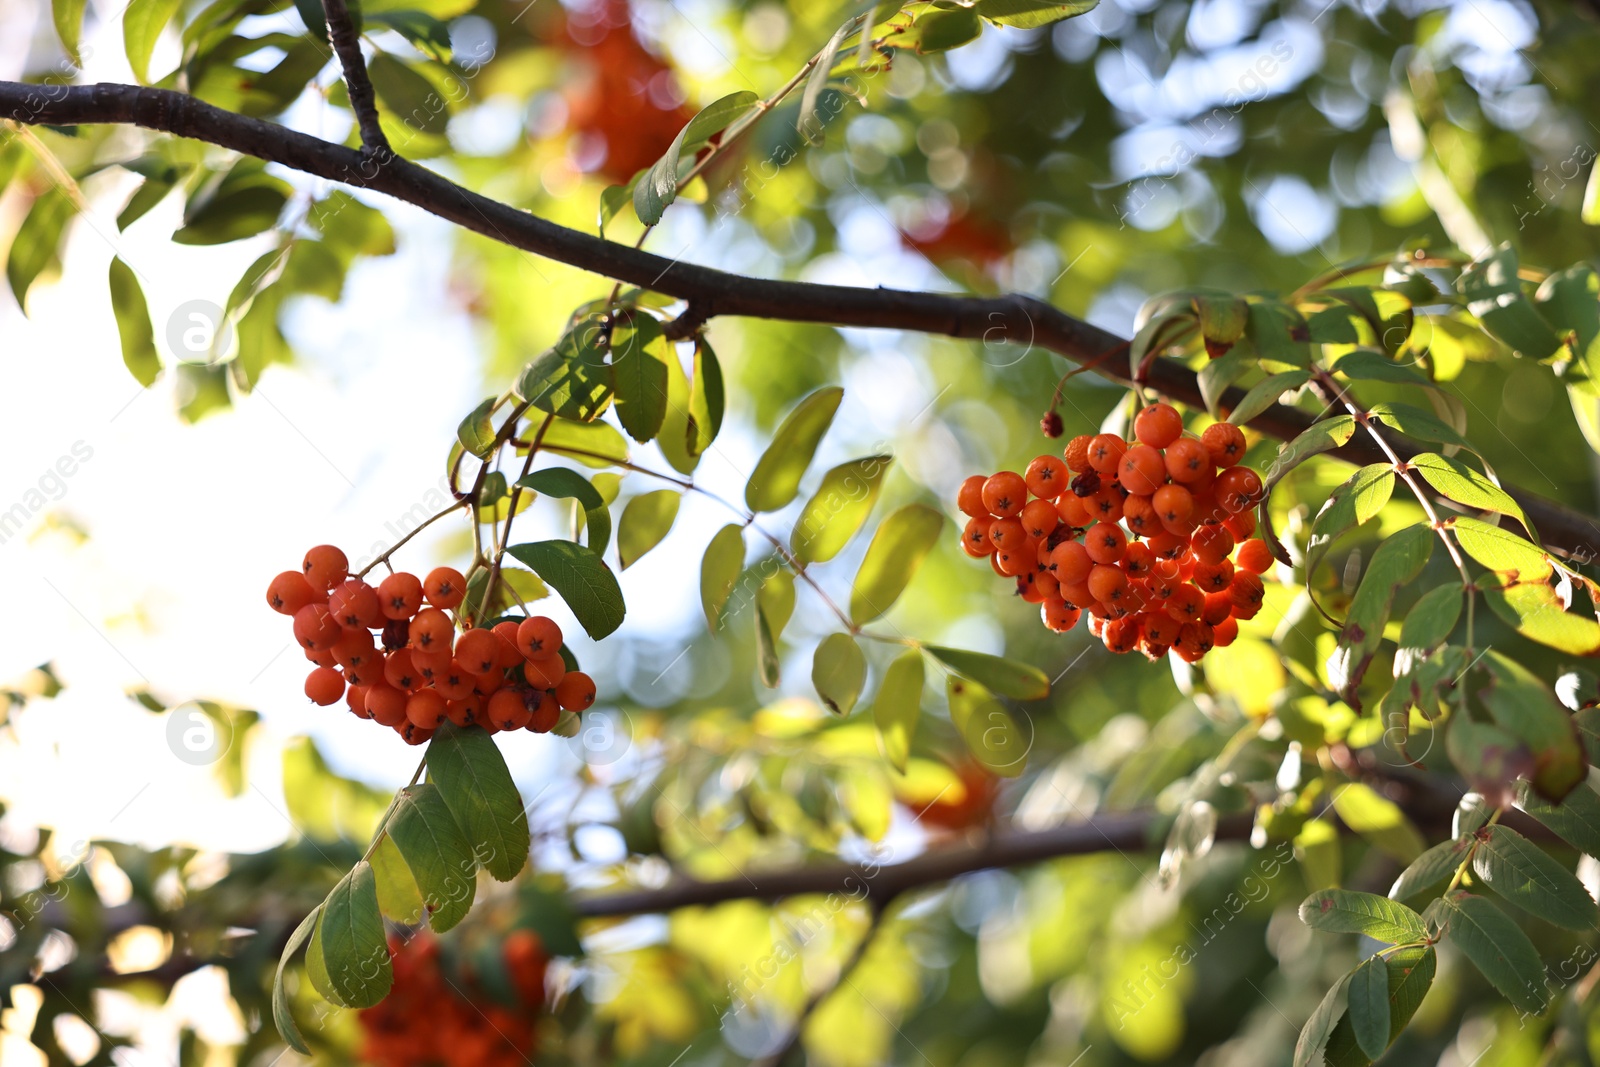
[427, 723, 531, 881]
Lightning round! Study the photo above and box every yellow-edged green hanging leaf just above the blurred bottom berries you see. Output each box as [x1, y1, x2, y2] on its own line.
[306, 859, 394, 1008]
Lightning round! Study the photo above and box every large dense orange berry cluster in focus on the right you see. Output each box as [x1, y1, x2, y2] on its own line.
[957, 403, 1272, 662]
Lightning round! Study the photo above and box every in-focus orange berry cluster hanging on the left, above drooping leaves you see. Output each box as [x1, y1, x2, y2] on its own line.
[267, 544, 595, 744]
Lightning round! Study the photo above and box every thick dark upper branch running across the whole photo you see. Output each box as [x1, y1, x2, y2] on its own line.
[0, 82, 1600, 558]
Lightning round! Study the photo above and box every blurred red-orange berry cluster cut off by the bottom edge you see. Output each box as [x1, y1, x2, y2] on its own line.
[358, 929, 549, 1067]
